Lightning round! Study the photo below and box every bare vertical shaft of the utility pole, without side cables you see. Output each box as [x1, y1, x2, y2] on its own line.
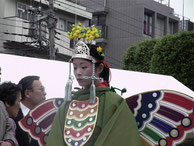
[48, 0, 56, 60]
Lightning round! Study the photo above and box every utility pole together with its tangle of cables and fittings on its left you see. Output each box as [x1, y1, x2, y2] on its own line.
[29, 0, 56, 60]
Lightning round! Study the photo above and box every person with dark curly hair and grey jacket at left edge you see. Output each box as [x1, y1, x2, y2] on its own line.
[0, 82, 21, 146]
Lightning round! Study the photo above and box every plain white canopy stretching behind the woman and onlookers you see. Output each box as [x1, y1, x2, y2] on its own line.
[0, 54, 194, 99]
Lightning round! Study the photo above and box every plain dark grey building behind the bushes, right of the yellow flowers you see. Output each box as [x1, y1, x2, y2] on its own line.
[80, 0, 179, 68]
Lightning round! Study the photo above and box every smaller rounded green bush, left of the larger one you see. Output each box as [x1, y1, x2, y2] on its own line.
[122, 39, 157, 72]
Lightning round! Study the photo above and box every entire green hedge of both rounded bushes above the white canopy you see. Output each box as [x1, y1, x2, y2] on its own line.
[123, 31, 194, 90]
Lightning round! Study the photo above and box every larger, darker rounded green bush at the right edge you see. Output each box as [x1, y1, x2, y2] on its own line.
[150, 31, 194, 90]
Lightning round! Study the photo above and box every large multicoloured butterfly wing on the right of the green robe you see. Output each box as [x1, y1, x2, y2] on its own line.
[126, 90, 194, 146]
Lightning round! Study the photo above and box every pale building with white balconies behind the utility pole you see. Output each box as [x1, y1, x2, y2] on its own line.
[0, 0, 92, 61]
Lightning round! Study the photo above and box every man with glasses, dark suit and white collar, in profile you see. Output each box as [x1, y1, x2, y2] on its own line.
[14, 76, 46, 146]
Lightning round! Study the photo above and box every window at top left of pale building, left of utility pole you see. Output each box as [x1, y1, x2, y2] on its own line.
[17, 3, 29, 20]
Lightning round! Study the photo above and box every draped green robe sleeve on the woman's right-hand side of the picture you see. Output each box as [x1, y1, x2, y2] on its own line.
[95, 100, 141, 146]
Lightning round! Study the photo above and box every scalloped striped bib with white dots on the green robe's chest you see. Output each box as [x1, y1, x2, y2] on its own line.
[64, 97, 99, 146]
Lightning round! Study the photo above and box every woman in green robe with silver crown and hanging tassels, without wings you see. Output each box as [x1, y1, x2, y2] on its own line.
[46, 25, 141, 146]
